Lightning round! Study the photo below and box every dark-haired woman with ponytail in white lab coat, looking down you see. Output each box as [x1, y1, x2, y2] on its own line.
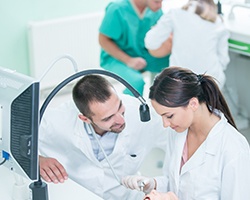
[123, 67, 250, 200]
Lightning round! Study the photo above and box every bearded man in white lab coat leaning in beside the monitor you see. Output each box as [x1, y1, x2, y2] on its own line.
[39, 75, 166, 200]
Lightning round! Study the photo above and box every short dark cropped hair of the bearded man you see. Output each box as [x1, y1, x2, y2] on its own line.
[72, 75, 113, 118]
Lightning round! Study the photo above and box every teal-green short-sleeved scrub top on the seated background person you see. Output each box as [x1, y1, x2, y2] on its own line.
[99, 0, 169, 72]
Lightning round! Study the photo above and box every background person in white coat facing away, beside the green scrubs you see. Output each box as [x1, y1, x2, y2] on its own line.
[145, 0, 230, 89]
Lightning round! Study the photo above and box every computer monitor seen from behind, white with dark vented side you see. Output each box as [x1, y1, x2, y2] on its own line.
[0, 67, 39, 180]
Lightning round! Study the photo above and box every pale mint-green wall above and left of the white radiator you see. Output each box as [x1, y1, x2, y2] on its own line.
[0, 0, 110, 75]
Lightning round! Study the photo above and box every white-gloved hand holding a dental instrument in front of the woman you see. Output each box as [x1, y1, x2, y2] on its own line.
[122, 175, 155, 194]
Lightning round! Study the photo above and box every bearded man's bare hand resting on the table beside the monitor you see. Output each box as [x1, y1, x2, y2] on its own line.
[39, 156, 68, 183]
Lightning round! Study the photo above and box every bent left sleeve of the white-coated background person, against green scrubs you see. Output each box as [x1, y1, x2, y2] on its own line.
[144, 12, 173, 50]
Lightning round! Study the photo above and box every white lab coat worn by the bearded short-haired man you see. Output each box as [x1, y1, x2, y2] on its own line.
[39, 95, 167, 200]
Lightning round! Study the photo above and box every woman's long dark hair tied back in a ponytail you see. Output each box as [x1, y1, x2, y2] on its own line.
[149, 67, 237, 129]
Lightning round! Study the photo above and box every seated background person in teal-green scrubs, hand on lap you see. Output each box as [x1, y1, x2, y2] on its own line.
[99, 0, 171, 95]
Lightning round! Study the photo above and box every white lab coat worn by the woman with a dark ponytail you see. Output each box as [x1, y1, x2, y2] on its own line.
[157, 111, 250, 200]
